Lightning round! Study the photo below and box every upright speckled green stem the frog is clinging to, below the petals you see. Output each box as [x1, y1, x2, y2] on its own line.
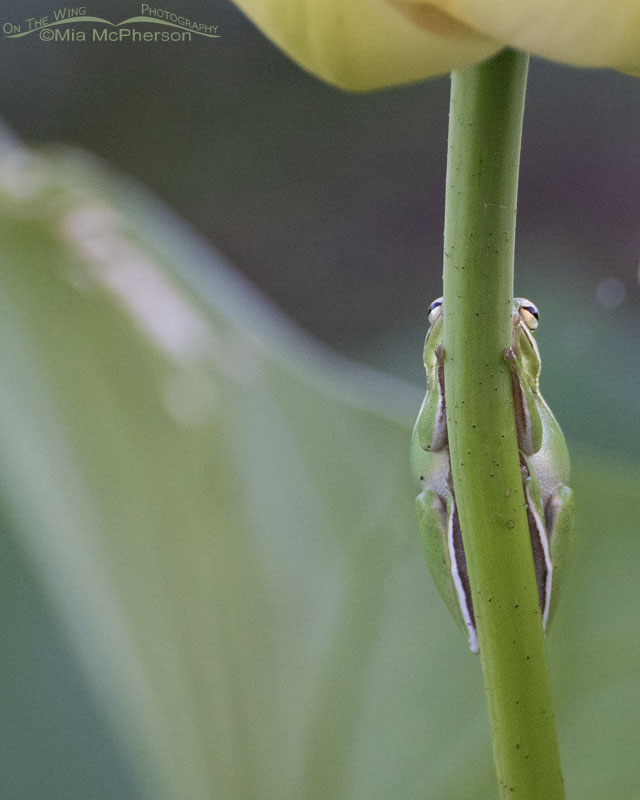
[444, 50, 564, 800]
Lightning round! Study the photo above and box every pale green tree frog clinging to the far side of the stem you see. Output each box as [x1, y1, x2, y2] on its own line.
[411, 298, 574, 652]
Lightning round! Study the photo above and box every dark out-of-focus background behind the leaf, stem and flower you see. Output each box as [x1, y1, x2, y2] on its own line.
[0, 0, 640, 800]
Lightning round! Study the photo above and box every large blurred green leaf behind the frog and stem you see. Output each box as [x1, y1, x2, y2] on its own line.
[0, 148, 640, 800]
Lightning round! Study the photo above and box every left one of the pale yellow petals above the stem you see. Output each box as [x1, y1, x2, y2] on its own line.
[230, 0, 503, 90]
